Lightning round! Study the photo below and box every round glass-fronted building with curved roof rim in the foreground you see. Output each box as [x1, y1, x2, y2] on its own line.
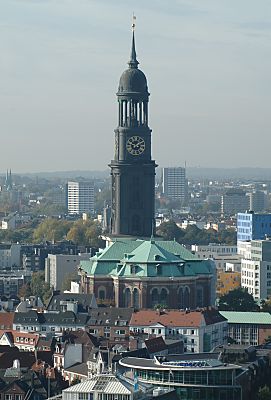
[120, 353, 242, 400]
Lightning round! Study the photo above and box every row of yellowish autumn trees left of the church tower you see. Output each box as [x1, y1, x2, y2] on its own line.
[0, 218, 103, 248]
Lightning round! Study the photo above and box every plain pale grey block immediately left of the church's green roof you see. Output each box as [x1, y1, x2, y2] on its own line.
[45, 253, 90, 290]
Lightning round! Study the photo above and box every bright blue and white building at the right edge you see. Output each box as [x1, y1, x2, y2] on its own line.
[237, 211, 271, 241]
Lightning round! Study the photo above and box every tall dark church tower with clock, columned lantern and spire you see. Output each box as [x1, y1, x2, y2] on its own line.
[110, 24, 157, 237]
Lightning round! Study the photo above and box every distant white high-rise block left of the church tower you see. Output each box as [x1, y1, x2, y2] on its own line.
[67, 181, 94, 214]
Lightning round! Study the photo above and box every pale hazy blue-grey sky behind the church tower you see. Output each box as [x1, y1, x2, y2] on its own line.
[0, 0, 271, 173]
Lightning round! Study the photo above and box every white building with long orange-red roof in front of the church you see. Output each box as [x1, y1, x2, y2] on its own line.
[130, 309, 228, 353]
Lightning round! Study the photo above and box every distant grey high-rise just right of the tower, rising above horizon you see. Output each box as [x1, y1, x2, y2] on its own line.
[162, 167, 187, 204]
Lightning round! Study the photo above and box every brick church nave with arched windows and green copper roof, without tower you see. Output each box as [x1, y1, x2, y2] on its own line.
[80, 238, 216, 309]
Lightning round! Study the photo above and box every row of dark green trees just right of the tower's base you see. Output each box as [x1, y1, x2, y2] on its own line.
[157, 221, 236, 245]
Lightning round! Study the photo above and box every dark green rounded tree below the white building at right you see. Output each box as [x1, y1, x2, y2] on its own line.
[218, 288, 259, 311]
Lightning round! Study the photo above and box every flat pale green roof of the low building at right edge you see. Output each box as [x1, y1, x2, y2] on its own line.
[219, 311, 271, 325]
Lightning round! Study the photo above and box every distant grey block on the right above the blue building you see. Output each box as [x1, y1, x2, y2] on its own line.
[221, 189, 249, 215]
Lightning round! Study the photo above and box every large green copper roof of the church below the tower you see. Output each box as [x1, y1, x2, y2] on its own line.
[80, 240, 212, 278]
